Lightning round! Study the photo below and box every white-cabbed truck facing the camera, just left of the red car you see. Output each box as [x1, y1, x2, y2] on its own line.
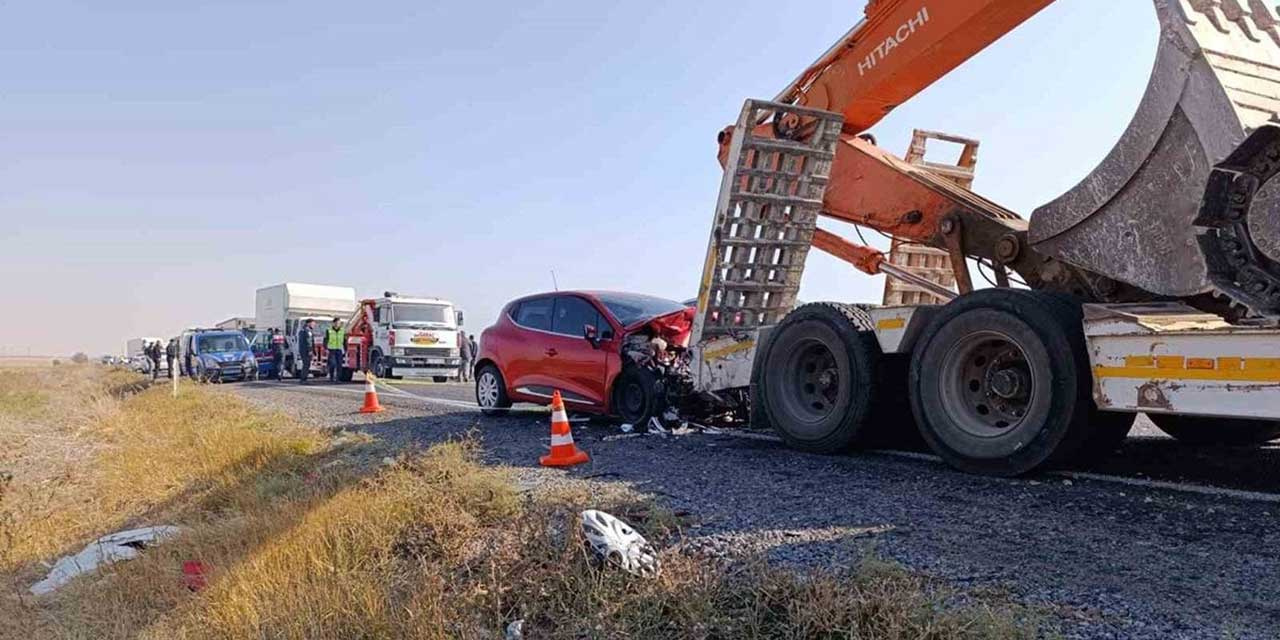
[343, 292, 463, 383]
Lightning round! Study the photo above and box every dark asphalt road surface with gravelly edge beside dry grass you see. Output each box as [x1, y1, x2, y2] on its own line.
[228, 383, 1280, 639]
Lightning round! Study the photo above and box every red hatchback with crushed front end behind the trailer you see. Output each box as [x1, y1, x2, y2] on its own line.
[475, 291, 694, 425]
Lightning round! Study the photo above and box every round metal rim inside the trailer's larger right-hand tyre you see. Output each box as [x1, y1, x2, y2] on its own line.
[941, 332, 1038, 438]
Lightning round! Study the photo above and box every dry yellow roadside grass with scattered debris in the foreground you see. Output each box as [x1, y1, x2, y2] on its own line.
[0, 372, 1034, 639]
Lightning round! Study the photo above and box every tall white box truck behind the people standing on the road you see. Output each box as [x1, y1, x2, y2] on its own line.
[253, 283, 356, 376]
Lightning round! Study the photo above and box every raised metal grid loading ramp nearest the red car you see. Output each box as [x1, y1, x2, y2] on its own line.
[692, 100, 844, 343]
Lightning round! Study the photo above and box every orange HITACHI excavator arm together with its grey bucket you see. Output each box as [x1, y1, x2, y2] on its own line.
[719, 0, 1280, 320]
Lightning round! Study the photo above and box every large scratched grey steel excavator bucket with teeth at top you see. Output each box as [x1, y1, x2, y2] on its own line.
[1029, 0, 1280, 316]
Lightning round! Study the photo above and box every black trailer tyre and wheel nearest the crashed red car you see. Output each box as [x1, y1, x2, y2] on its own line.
[751, 302, 881, 453]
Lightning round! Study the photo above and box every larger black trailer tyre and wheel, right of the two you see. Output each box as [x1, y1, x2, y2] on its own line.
[909, 288, 1102, 476]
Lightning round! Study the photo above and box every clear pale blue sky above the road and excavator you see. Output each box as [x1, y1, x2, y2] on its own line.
[0, 0, 1157, 355]
